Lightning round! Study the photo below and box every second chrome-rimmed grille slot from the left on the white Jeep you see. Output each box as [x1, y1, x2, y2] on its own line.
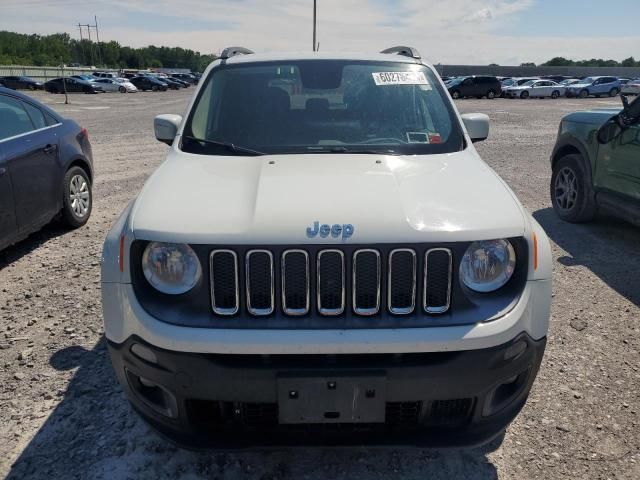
[246, 250, 274, 316]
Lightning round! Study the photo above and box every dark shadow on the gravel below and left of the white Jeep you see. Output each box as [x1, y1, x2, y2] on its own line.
[7, 338, 503, 480]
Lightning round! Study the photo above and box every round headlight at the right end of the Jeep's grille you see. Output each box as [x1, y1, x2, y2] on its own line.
[460, 240, 516, 293]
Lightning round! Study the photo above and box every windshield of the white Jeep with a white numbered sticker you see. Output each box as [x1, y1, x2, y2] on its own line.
[182, 60, 464, 155]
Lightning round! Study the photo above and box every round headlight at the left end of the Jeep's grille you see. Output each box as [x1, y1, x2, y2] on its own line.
[142, 242, 202, 295]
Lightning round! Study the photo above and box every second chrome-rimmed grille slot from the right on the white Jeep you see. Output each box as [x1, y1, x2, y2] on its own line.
[388, 248, 417, 315]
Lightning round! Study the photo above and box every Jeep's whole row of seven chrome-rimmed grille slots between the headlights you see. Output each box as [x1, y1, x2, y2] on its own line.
[210, 247, 453, 317]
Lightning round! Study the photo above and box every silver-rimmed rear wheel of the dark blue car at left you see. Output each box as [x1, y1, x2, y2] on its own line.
[62, 167, 93, 228]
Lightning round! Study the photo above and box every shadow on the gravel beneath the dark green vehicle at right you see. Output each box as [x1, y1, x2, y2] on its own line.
[533, 208, 640, 306]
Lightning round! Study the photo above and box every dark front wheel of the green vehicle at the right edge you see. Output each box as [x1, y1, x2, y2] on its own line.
[551, 154, 597, 223]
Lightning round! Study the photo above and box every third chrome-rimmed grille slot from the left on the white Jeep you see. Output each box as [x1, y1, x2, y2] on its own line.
[282, 250, 309, 316]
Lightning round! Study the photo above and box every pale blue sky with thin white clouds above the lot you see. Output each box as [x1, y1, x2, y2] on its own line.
[0, 0, 640, 65]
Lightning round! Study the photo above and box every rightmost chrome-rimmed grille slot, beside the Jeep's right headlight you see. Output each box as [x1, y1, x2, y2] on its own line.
[423, 248, 452, 314]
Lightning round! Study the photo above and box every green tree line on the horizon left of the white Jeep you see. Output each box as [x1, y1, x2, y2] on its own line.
[0, 31, 216, 72]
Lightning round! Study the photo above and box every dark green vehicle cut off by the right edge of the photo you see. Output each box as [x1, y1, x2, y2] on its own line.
[551, 97, 640, 225]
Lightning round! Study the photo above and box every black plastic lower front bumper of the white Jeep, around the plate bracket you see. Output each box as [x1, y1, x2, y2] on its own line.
[109, 333, 546, 448]
